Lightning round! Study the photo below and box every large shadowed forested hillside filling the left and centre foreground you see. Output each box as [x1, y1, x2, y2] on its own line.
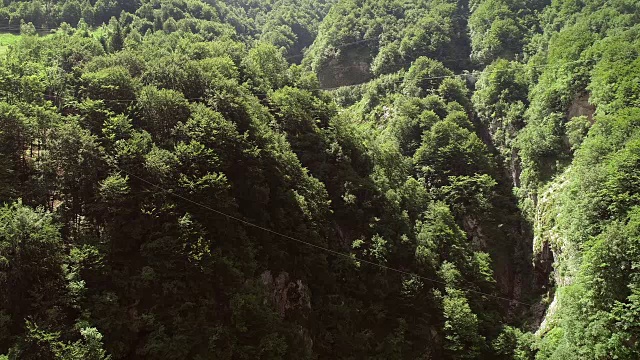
[0, 1, 530, 359]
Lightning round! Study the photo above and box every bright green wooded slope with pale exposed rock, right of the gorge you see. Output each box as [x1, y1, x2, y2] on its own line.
[474, 1, 640, 359]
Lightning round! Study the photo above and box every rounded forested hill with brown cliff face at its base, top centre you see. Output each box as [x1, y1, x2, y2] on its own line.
[306, 0, 470, 87]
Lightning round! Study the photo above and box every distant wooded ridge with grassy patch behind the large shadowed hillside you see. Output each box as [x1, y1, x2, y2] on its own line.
[0, 0, 335, 57]
